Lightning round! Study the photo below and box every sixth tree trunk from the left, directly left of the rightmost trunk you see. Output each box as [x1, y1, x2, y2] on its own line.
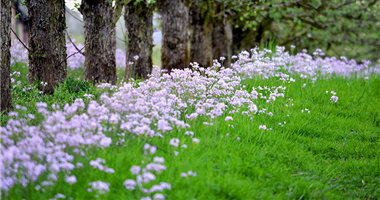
[190, 0, 213, 67]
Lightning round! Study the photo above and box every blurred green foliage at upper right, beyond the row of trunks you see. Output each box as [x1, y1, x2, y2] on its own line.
[215, 0, 380, 61]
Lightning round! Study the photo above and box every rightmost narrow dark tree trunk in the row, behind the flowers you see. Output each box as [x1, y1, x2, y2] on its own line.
[212, 23, 232, 67]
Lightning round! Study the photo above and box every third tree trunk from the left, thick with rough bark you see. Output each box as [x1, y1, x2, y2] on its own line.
[80, 0, 117, 84]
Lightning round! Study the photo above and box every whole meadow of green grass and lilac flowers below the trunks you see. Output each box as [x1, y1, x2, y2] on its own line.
[0, 41, 380, 200]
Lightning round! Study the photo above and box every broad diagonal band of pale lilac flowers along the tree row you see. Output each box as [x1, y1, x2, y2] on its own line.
[0, 44, 380, 199]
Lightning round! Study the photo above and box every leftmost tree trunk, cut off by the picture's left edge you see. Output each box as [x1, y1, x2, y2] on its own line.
[0, 0, 12, 113]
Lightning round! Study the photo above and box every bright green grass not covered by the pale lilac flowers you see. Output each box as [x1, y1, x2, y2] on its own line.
[0, 56, 380, 199]
